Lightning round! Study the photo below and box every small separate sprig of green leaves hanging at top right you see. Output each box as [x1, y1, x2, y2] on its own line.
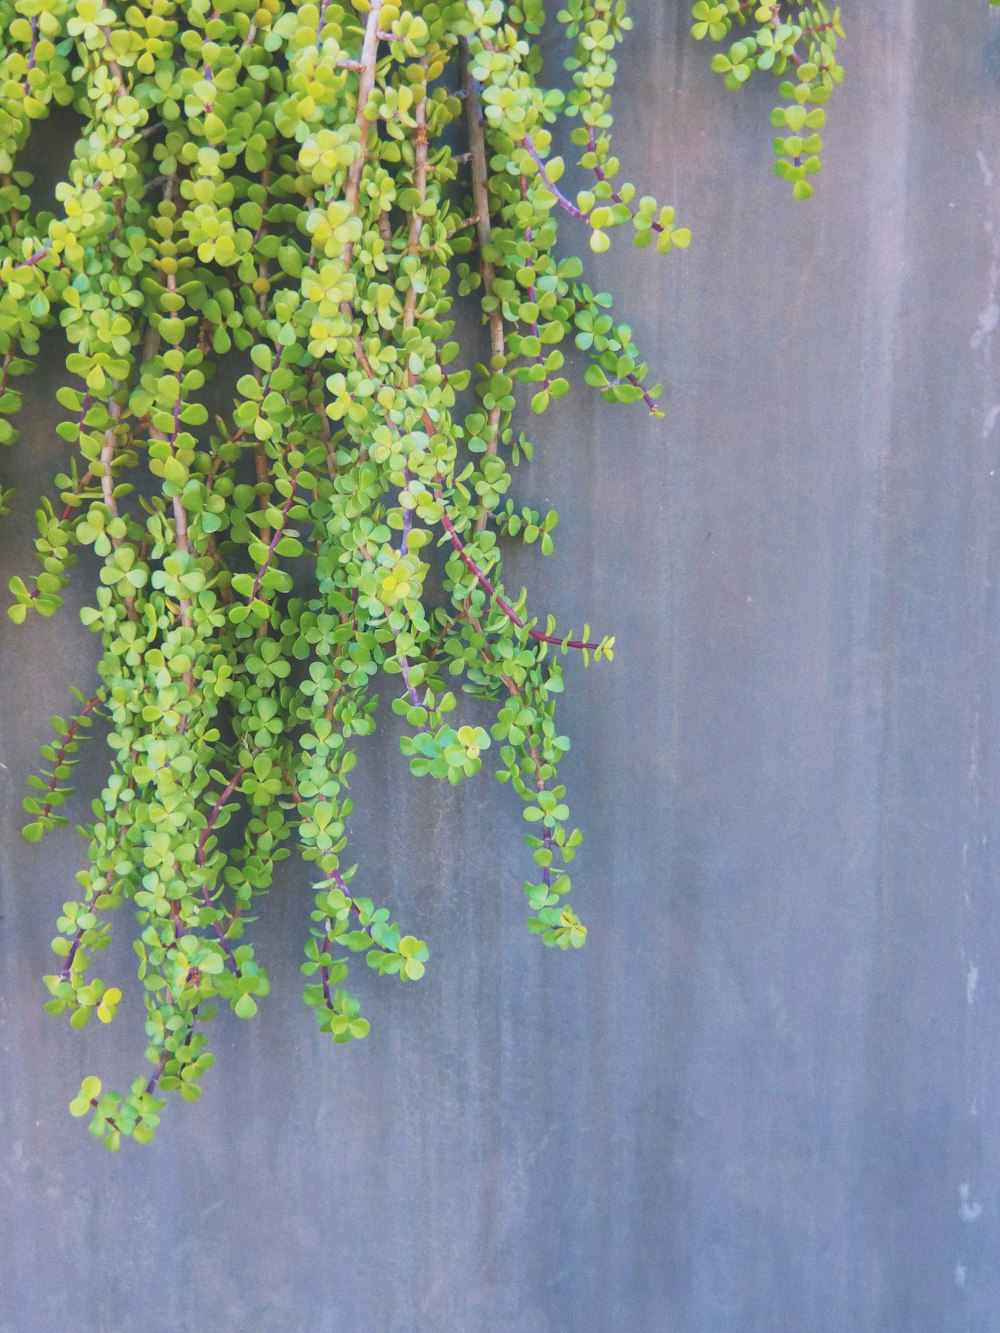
[691, 0, 848, 199]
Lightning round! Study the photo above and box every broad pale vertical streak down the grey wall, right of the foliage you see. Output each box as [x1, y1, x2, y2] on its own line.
[844, 0, 915, 1329]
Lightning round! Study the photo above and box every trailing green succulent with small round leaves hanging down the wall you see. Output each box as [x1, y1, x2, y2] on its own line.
[0, 0, 848, 1149]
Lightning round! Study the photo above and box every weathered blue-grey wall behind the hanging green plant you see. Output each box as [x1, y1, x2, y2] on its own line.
[0, 0, 1000, 1333]
